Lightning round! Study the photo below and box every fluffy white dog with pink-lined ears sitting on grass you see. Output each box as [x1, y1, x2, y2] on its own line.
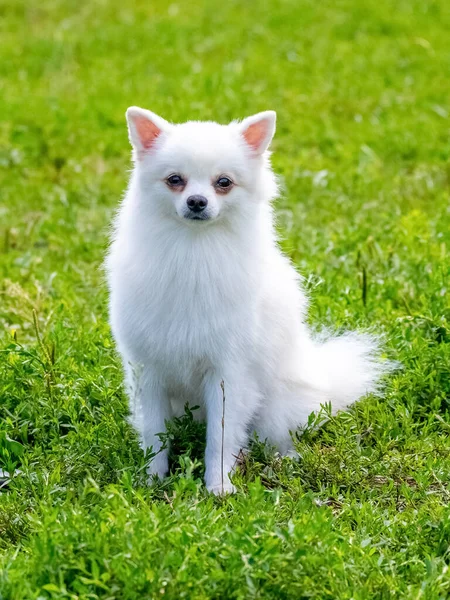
[106, 107, 387, 494]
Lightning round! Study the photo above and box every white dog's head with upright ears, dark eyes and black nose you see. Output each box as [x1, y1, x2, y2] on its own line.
[126, 107, 276, 227]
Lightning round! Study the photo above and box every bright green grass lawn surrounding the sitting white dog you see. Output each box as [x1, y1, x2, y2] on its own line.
[0, 0, 450, 600]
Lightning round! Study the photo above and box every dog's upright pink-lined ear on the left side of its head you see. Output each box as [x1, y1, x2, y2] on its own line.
[126, 106, 171, 159]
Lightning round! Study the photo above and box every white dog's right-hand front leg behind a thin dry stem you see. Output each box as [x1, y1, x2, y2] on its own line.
[204, 373, 253, 494]
